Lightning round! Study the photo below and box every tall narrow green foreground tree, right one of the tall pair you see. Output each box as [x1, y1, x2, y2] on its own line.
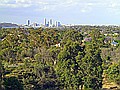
[82, 31, 103, 90]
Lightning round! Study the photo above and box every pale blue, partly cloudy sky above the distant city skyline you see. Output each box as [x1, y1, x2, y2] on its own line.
[0, 0, 120, 24]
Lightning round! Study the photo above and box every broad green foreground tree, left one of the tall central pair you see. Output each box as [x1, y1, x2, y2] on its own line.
[56, 41, 82, 90]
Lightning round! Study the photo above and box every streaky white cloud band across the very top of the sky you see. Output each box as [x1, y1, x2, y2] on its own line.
[0, 0, 120, 13]
